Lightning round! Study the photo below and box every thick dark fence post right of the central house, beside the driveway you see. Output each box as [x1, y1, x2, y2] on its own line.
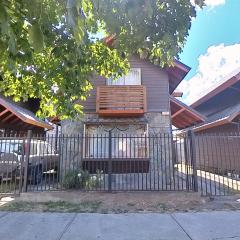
[188, 130, 198, 192]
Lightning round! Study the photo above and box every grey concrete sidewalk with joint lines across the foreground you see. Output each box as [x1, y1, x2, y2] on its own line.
[0, 211, 240, 240]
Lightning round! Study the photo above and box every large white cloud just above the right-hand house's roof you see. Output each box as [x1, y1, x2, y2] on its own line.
[178, 44, 240, 104]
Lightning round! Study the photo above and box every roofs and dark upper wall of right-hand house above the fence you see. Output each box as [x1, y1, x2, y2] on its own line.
[191, 69, 240, 134]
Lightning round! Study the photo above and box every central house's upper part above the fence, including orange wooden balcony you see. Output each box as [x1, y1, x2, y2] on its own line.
[62, 56, 203, 135]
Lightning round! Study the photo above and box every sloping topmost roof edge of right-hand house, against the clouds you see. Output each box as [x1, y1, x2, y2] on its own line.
[191, 68, 240, 108]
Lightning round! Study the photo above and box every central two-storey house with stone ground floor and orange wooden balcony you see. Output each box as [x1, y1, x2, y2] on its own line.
[58, 55, 204, 184]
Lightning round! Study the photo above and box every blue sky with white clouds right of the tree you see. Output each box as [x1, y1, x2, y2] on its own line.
[178, 0, 240, 104]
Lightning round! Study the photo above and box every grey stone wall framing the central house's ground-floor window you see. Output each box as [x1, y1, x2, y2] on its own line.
[61, 112, 173, 187]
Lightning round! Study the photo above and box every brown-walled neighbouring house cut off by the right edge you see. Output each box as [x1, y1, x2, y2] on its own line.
[181, 69, 240, 176]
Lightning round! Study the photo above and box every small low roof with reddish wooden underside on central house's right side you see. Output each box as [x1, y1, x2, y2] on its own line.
[170, 96, 205, 129]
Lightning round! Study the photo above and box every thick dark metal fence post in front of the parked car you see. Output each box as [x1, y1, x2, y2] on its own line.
[21, 130, 32, 192]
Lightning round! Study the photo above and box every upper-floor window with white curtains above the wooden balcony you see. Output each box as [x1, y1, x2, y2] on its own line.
[107, 68, 141, 85]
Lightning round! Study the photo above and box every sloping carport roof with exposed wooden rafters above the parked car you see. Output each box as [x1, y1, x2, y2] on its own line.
[0, 97, 53, 130]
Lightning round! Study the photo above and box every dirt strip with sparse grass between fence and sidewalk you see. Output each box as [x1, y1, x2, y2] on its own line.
[0, 192, 240, 213]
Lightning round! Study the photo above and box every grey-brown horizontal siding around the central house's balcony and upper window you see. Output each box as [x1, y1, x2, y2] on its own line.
[83, 56, 170, 112]
